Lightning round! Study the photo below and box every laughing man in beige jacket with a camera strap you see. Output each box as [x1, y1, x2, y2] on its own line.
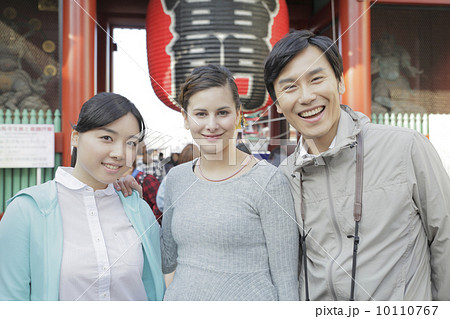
[264, 31, 450, 300]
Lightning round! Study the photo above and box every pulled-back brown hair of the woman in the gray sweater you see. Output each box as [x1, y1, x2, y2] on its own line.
[178, 64, 241, 111]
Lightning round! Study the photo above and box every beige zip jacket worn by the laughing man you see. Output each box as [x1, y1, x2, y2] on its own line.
[280, 106, 450, 300]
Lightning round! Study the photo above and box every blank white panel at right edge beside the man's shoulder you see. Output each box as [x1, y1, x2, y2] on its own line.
[429, 114, 450, 175]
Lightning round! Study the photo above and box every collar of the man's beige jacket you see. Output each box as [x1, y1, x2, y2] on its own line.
[294, 105, 369, 171]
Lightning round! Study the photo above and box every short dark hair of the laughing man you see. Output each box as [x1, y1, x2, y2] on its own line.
[264, 30, 344, 102]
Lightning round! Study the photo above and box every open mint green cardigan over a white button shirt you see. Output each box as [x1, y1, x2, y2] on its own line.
[0, 180, 165, 300]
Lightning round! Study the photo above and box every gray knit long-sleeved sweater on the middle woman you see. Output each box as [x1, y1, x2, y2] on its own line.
[161, 161, 299, 300]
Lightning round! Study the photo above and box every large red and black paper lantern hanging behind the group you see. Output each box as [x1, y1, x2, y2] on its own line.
[146, 0, 289, 113]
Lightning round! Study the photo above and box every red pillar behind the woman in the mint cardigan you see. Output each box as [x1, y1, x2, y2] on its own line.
[61, 0, 97, 166]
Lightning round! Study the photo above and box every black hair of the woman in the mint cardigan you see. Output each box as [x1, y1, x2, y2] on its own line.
[71, 92, 145, 167]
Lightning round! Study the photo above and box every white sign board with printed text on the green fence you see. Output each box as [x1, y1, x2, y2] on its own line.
[0, 124, 55, 168]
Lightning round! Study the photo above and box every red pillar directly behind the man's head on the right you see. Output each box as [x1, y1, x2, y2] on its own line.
[339, 0, 371, 117]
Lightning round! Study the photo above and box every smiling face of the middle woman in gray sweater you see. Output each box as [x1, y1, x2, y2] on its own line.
[182, 85, 239, 154]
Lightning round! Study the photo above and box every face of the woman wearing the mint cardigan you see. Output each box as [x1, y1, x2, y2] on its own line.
[72, 113, 140, 190]
